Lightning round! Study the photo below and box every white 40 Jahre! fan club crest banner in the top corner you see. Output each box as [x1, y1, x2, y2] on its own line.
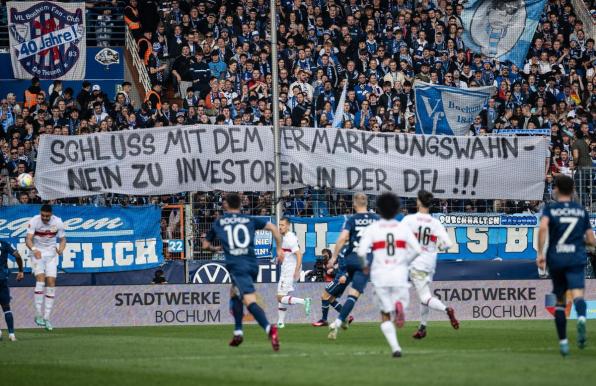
[7, 1, 87, 80]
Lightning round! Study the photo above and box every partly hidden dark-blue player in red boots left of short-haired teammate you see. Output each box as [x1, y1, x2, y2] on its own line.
[312, 249, 354, 327]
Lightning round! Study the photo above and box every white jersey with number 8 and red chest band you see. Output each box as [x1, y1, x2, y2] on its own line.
[357, 219, 422, 287]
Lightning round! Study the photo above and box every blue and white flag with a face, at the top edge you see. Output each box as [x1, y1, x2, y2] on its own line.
[461, 0, 546, 67]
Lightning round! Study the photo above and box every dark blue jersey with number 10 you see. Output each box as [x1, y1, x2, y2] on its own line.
[206, 213, 268, 262]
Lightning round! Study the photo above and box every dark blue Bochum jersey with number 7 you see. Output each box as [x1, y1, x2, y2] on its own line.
[542, 202, 592, 268]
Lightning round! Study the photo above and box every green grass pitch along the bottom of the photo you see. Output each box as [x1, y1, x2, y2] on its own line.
[0, 320, 596, 386]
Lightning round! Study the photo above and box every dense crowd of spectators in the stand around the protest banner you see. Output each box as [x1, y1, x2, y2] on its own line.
[0, 0, 596, 219]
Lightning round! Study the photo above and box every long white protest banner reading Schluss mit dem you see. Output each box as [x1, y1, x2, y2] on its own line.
[36, 126, 547, 200]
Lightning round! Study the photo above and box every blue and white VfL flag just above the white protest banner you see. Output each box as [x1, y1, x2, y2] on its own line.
[414, 81, 495, 135]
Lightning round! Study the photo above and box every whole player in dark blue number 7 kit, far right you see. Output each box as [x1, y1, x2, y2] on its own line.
[536, 175, 596, 356]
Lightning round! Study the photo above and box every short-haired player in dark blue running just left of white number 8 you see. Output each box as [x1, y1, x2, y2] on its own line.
[328, 193, 380, 339]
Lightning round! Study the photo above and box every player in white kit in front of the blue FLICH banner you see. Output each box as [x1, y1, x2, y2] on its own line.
[25, 204, 66, 331]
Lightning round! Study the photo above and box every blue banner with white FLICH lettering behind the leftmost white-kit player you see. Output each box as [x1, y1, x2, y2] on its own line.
[0, 205, 163, 273]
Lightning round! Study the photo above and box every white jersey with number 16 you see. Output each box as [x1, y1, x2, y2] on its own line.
[402, 213, 453, 273]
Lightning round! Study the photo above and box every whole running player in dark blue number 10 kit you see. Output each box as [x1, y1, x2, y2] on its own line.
[203, 193, 283, 351]
